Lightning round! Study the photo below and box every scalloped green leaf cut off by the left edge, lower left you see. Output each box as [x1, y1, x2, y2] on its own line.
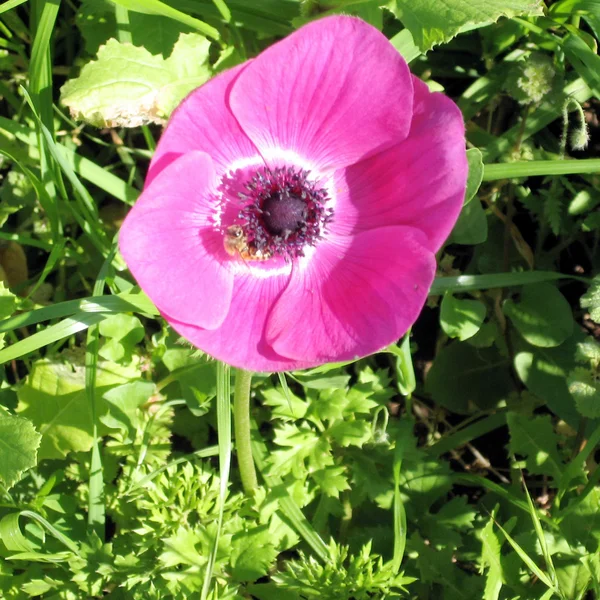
[0, 414, 42, 488]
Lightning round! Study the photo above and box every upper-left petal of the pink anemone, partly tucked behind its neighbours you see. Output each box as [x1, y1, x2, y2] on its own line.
[146, 62, 258, 185]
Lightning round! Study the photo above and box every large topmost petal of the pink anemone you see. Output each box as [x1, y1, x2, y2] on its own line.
[230, 16, 413, 170]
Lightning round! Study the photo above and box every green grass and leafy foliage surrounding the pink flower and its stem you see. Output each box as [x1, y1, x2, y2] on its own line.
[0, 0, 600, 600]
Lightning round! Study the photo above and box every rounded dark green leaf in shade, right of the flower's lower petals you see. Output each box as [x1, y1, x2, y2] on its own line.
[503, 283, 573, 348]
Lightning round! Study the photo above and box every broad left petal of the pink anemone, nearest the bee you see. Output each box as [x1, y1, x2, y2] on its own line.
[119, 152, 233, 329]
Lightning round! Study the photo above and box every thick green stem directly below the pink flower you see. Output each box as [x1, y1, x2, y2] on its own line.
[233, 369, 258, 495]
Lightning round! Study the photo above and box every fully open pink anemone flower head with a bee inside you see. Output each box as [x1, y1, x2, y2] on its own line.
[120, 16, 467, 371]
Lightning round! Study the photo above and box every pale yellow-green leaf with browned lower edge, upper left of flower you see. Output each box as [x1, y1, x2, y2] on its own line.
[61, 34, 211, 127]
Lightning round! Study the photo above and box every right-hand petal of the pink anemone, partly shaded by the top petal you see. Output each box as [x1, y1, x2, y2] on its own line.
[332, 77, 468, 252]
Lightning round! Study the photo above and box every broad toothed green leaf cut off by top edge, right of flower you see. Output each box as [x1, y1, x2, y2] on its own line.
[388, 0, 544, 52]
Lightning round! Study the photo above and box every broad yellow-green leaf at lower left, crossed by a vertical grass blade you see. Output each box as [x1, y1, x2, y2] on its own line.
[17, 359, 139, 460]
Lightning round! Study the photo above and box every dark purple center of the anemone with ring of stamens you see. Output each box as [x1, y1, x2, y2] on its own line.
[233, 167, 332, 260]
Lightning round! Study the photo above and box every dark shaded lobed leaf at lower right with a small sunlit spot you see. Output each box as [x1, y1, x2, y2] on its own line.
[506, 413, 564, 481]
